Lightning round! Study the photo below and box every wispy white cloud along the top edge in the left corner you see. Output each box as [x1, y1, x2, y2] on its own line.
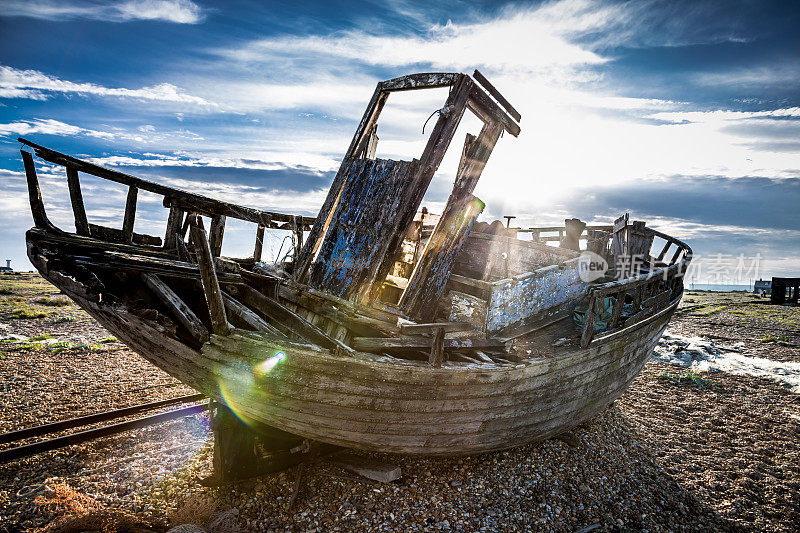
[2, 0, 203, 24]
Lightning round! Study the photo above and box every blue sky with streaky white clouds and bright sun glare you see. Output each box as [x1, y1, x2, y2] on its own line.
[0, 0, 800, 284]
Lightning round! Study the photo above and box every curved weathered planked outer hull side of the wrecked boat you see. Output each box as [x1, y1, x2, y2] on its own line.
[42, 256, 678, 455]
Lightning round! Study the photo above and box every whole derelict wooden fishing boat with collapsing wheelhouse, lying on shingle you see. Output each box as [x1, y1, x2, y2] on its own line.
[20, 71, 691, 462]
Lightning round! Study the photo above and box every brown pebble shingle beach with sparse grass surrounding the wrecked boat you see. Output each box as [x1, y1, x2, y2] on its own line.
[0, 275, 800, 532]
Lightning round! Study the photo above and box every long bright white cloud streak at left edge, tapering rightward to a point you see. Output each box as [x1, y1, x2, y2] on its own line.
[0, 66, 217, 107]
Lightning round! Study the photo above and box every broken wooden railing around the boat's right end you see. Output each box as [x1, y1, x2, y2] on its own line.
[581, 227, 692, 348]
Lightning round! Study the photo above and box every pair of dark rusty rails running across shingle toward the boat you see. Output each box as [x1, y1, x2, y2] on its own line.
[0, 394, 208, 463]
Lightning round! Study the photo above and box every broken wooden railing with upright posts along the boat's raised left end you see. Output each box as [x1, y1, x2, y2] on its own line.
[18, 138, 315, 261]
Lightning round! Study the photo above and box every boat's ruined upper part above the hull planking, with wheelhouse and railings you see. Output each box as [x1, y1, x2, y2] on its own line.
[19, 71, 691, 367]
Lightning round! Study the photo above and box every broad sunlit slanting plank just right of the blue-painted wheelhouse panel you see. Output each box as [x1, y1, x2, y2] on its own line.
[399, 194, 484, 321]
